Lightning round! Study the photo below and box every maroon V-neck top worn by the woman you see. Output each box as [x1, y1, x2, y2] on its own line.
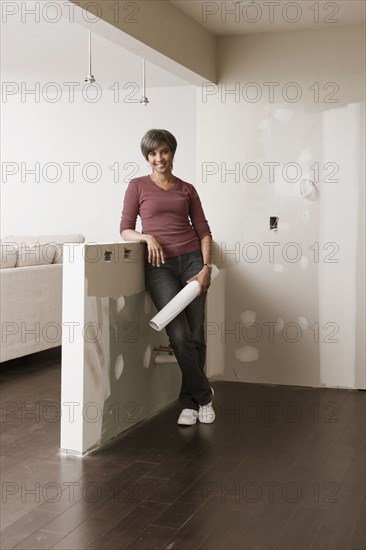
[120, 176, 211, 258]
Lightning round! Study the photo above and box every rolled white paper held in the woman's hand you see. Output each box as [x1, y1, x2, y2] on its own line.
[150, 265, 219, 331]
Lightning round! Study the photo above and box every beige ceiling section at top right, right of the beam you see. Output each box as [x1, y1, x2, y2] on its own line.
[170, 0, 366, 36]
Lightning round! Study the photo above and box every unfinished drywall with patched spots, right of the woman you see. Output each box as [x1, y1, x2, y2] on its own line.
[197, 25, 365, 387]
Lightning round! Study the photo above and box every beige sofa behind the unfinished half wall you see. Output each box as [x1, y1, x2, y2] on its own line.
[0, 234, 85, 362]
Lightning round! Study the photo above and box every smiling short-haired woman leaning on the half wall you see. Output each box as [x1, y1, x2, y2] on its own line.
[120, 130, 215, 426]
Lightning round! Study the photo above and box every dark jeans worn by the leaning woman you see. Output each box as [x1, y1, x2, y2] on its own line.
[145, 251, 212, 410]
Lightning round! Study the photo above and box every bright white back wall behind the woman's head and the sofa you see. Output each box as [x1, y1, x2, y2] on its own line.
[1, 86, 196, 242]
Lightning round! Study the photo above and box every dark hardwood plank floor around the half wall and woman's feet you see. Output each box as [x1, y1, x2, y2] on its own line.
[0, 350, 366, 550]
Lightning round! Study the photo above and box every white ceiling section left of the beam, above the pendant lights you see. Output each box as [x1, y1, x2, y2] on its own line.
[1, 3, 187, 87]
